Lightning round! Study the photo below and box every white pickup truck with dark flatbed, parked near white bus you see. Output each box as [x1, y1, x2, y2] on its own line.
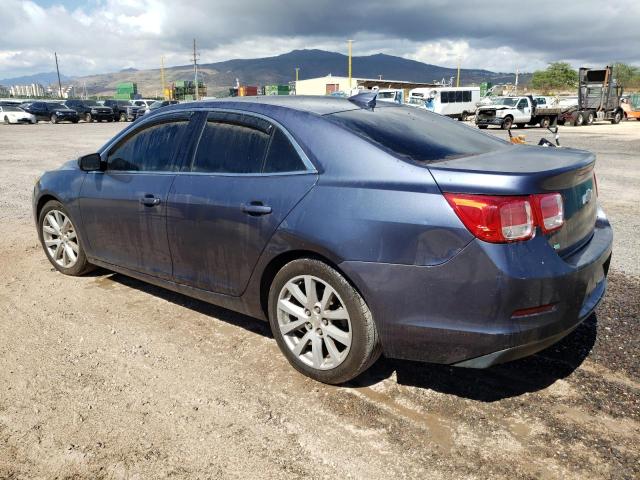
[476, 95, 563, 130]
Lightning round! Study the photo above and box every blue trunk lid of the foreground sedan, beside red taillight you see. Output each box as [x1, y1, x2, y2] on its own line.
[429, 145, 597, 256]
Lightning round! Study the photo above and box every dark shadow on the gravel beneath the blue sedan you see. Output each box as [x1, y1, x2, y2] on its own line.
[96, 270, 597, 402]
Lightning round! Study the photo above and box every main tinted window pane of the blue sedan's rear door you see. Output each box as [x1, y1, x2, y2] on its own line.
[192, 114, 270, 173]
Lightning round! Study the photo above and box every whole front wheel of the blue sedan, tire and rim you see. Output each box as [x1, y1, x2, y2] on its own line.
[38, 200, 93, 276]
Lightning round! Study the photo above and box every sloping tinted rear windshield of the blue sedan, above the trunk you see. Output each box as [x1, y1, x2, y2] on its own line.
[325, 106, 507, 164]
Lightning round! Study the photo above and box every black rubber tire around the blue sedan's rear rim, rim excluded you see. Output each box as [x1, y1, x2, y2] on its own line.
[269, 258, 382, 385]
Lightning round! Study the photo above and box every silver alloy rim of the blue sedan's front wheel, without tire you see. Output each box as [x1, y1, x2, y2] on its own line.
[42, 210, 80, 268]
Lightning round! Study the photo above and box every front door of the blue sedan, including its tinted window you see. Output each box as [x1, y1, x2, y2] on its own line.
[80, 113, 195, 278]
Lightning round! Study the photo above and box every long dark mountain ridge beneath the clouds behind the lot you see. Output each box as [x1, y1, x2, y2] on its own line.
[67, 50, 530, 96]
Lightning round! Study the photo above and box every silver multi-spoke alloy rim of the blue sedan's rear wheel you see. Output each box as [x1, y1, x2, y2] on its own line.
[277, 275, 352, 370]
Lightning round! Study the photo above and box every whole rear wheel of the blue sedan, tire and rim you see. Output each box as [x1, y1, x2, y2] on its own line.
[269, 259, 381, 384]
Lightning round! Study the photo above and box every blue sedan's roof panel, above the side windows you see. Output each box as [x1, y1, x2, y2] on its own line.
[163, 95, 393, 115]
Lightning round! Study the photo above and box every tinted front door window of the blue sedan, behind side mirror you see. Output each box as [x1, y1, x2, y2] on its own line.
[107, 120, 189, 172]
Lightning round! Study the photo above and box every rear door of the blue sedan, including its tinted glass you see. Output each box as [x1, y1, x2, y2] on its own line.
[167, 112, 317, 296]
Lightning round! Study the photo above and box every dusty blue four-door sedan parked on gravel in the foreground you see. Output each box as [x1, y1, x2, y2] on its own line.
[33, 95, 612, 383]
